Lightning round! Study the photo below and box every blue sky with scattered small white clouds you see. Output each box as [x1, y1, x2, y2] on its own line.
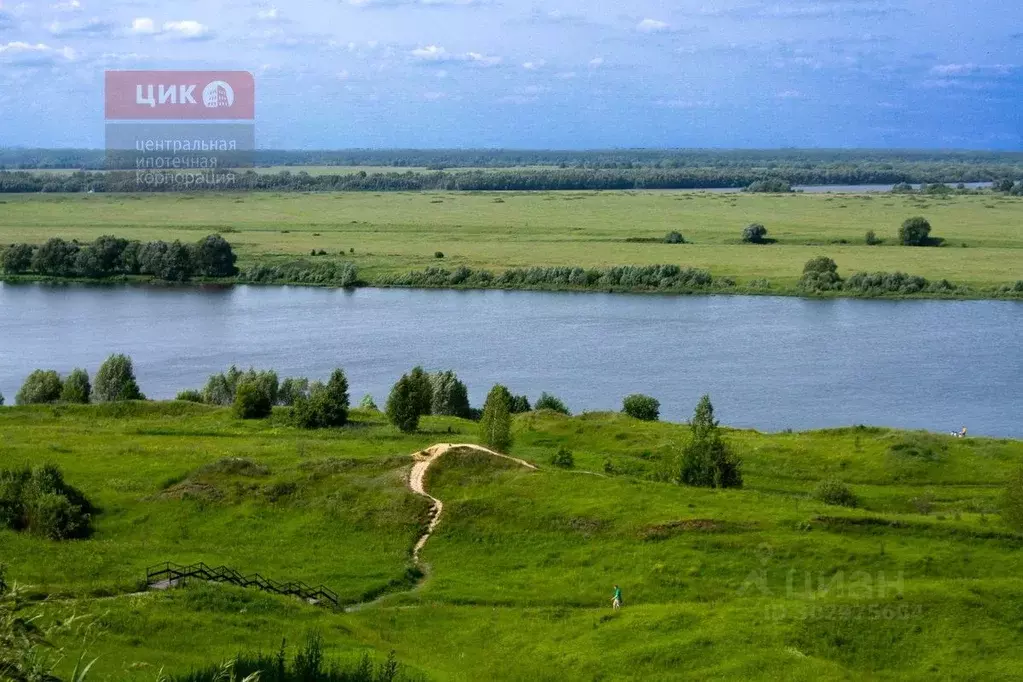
[0, 0, 1023, 149]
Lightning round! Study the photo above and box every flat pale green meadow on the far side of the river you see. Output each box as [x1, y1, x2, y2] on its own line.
[0, 191, 1023, 292]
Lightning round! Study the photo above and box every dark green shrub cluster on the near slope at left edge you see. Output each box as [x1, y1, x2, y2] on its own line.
[0, 464, 93, 540]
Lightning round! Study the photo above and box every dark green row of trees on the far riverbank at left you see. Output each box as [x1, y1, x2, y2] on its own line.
[0, 234, 237, 281]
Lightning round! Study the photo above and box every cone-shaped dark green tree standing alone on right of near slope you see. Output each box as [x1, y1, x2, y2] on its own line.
[676, 396, 743, 488]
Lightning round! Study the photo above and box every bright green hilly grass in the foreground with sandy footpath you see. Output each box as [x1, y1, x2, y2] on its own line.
[0, 403, 1023, 680]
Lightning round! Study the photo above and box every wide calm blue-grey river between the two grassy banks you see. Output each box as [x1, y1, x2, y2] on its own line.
[0, 284, 1023, 438]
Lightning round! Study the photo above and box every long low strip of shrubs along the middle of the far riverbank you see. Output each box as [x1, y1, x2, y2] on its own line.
[384, 265, 714, 290]
